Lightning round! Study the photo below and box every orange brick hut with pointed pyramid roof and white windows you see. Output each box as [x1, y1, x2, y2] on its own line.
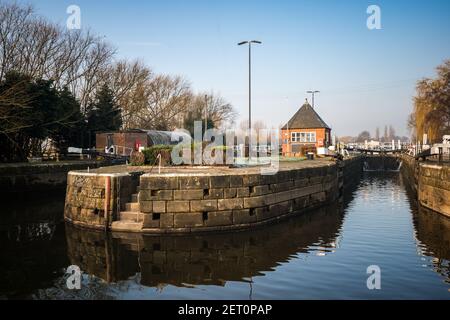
[281, 100, 331, 156]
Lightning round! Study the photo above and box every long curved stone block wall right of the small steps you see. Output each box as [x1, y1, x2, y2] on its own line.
[139, 162, 338, 232]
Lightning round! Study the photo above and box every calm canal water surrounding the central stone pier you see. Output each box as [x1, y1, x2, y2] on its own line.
[0, 173, 450, 299]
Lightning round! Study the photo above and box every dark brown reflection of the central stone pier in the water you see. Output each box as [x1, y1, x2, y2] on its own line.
[67, 206, 343, 286]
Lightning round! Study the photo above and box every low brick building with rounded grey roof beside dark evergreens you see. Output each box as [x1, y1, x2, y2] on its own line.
[95, 129, 190, 155]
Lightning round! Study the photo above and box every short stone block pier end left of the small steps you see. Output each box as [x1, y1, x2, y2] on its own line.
[64, 172, 138, 228]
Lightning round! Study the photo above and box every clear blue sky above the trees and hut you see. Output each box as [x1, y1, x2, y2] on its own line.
[20, 0, 450, 135]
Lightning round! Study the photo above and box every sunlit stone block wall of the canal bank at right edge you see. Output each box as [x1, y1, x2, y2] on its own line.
[418, 163, 450, 217]
